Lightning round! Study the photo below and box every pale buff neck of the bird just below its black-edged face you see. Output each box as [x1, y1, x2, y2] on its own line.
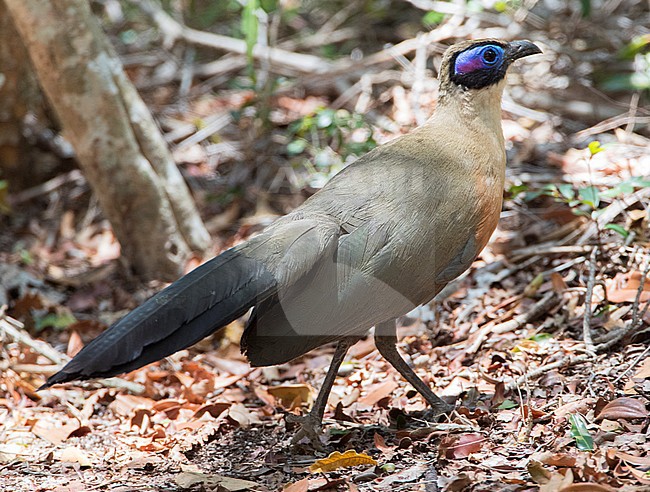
[434, 80, 505, 139]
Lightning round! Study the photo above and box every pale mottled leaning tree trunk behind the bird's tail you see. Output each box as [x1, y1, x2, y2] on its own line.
[4, 0, 210, 280]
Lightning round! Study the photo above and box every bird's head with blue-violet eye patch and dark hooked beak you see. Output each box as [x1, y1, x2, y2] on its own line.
[440, 39, 542, 103]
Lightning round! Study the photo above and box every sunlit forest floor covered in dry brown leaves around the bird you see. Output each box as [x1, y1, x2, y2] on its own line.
[0, 1, 650, 492]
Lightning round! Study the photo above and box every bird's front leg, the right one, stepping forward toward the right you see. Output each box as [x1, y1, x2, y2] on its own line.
[375, 320, 454, 416]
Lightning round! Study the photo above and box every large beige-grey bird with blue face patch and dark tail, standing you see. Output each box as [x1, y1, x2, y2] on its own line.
[39, 39, 541, 445]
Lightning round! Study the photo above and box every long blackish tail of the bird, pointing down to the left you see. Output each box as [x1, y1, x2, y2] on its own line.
[39, 249, 276, 389]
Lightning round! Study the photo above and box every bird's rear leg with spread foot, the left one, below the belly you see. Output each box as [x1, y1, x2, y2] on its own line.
[287, 337, 358, 450]
